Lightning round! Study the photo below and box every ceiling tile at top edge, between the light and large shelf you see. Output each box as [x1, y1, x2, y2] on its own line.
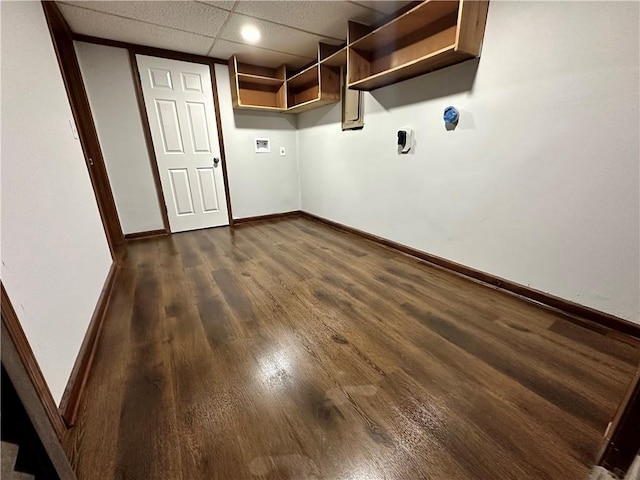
[235, 1, 385, 40]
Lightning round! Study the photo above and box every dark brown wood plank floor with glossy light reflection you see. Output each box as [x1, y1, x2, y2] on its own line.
[67, 218, 640, 480]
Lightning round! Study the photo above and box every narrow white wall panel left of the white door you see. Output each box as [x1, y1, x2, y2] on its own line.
[74, 42, 164, 233]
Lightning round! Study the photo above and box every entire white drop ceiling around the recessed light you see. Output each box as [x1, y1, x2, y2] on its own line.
[56, 0, 411, 68]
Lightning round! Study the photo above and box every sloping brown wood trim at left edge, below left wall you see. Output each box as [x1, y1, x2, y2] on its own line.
[0, 283, 66, 440]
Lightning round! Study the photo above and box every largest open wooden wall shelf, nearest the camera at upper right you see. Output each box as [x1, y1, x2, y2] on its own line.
[347, 0, 488, 90]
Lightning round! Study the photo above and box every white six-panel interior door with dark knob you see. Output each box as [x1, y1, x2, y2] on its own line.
[136, 55, 229, 232]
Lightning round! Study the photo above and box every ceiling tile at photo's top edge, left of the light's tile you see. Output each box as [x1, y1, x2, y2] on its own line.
[64, 1, 229, 38]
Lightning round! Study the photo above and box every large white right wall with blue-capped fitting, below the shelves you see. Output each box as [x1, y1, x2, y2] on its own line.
[298, 1, 640, 322]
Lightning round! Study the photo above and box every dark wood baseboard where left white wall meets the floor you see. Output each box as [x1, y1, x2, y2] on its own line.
[60, 262, 118, 428]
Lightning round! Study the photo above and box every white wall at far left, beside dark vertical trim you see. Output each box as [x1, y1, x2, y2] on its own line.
[0, 2, 111, 402]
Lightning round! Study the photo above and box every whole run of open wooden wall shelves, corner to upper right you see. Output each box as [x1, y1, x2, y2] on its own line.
[229, 0, 489, 113]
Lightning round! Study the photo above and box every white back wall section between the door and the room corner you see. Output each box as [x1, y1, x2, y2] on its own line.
[215, 65, 300, 218]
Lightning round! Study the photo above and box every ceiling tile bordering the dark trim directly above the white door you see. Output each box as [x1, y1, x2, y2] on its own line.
[60, 4, 213, 55]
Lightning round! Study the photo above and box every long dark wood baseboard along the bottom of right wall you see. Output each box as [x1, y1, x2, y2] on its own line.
[300, 211, 640, 338]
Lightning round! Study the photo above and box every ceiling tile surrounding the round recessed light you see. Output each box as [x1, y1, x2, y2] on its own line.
[219, 13, 336, 57]
